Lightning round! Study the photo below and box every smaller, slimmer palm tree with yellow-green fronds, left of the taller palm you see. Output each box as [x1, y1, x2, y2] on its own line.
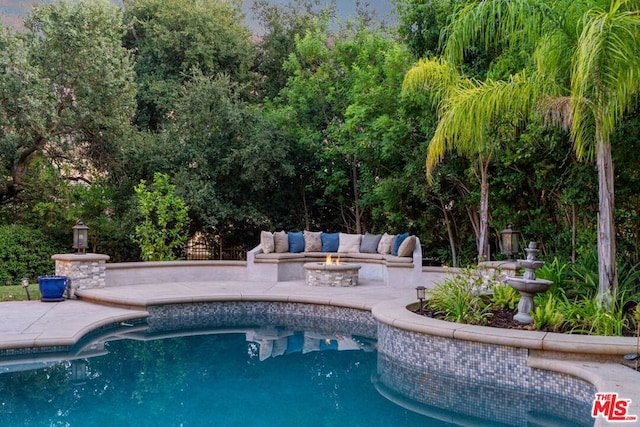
[403, 59, 537, 261]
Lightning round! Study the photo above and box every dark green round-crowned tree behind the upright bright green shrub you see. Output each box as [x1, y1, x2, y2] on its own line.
[118, 73, 293, 245]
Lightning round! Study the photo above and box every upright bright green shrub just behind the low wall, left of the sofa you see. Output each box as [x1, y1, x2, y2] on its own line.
[134, 173, 189, 261]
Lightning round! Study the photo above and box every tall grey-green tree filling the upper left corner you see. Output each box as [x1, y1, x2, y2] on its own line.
[0, 0, 135, 203]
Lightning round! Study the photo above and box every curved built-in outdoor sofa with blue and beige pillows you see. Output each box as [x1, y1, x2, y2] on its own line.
[247, 231, 422, 287]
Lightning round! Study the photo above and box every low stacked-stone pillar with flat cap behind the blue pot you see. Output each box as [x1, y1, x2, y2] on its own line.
[51, 254, 109, 299]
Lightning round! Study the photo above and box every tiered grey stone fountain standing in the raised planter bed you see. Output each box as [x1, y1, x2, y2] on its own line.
[507, 242, 553, 324]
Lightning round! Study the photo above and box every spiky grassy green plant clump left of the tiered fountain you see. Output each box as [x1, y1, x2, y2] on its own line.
[426, 269, 491, 325]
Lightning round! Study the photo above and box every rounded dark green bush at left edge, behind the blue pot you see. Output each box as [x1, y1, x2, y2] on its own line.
[0, 224, 60, 285]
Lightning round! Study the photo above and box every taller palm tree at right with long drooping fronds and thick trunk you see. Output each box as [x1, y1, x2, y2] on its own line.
[405, 0, 640, 307]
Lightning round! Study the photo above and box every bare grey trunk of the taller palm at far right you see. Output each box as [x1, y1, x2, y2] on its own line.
[596, 123, 618, 309]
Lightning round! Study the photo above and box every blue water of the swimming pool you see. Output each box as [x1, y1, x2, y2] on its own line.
[0, 328, 588, 427]
